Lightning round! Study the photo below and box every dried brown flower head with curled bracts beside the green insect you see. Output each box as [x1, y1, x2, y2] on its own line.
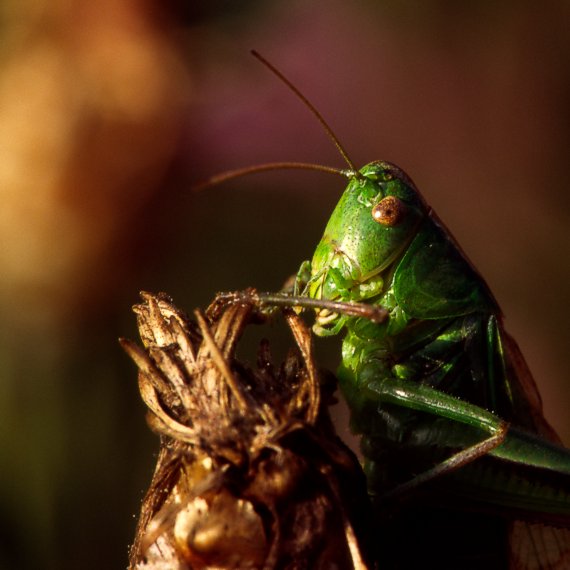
[121, 293, 370, 570]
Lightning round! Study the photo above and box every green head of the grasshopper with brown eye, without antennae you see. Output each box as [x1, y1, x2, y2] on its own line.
[305, 161, 428, 301]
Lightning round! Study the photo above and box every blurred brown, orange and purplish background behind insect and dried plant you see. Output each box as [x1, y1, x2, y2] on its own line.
[0, 0, 570, 570]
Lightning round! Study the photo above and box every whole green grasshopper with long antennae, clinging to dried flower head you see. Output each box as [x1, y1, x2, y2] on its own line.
[199, 53, 570, 569]
